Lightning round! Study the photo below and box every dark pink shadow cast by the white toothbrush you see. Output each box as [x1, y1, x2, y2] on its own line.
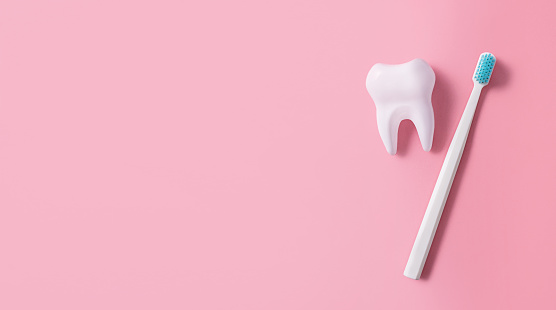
[420, 60, 510, 281]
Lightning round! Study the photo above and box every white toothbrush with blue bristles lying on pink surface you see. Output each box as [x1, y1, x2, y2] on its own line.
[404, 53, 496, 280]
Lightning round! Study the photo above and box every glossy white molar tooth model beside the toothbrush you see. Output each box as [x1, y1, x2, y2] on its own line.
[367, 58, 435, 155]
